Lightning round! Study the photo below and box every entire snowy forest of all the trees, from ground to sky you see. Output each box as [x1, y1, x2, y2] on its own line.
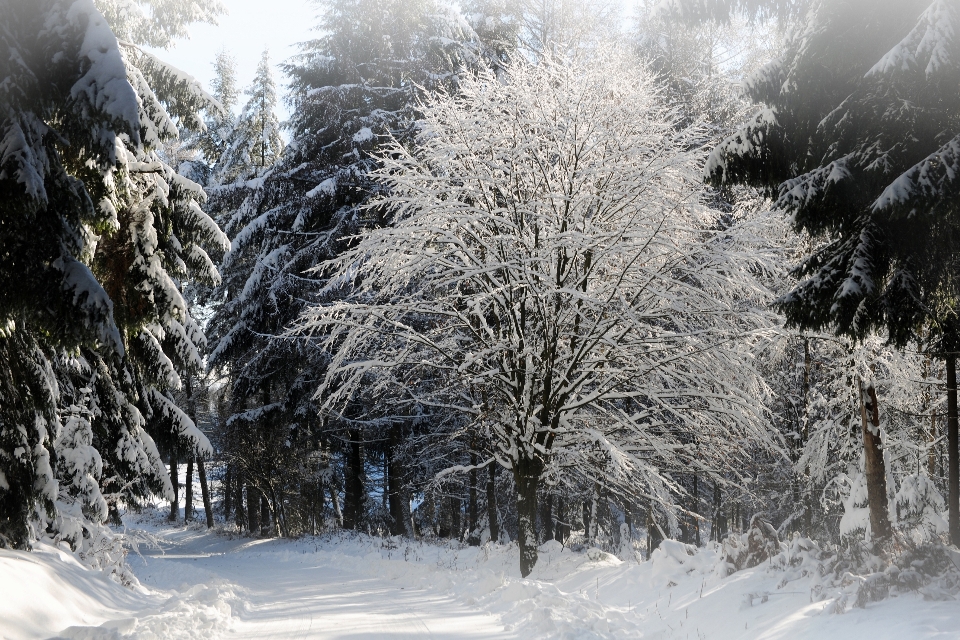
[0, 0, 960, 575]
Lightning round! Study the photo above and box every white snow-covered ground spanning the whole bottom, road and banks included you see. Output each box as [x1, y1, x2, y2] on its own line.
[0, 520, 960, 640]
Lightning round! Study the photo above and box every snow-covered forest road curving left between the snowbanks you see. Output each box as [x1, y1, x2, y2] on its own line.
[130, 529, 518, 640]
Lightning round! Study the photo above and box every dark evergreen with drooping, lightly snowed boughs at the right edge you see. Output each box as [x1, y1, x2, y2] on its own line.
[670, 0, 960, 542]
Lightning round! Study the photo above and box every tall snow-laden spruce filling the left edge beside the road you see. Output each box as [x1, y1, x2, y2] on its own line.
[0, 0, 222, 546]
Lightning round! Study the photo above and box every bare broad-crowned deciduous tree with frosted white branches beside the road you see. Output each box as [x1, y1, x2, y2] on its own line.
[300, 47, 769, 575]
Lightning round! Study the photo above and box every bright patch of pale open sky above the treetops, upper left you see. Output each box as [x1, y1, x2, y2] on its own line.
[147, 0, 316, 119]
